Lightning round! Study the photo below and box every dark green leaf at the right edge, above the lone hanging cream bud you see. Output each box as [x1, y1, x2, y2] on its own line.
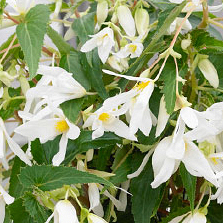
[191, 29, 223, 54]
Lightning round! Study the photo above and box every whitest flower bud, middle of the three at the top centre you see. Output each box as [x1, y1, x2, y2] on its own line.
[117, 5, 136, 37]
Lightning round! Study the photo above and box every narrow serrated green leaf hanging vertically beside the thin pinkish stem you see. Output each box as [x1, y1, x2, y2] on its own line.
[162, 58, 176, 114]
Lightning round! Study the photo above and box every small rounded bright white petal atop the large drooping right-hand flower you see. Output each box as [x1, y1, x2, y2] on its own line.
[180, 107, 198, 129]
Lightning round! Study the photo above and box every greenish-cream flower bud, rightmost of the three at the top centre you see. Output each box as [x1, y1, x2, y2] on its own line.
[135, 8, 149, 36]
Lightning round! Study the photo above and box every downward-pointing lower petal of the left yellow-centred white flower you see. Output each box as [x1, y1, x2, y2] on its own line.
[52, 134, 68, 166]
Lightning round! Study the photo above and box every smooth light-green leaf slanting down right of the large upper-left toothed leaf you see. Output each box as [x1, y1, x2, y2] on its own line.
[47, 26, 73, 54]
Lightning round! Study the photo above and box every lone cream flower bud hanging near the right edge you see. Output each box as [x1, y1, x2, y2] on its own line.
[198, 59, 219, 88]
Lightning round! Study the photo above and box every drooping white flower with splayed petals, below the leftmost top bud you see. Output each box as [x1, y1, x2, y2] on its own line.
[81, 27, 115, 63]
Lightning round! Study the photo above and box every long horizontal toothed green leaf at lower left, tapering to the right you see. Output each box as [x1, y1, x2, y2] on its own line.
[19, 166, 112, 191]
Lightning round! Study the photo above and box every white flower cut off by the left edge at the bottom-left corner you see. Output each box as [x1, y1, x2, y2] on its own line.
[0, 184, 15, 223]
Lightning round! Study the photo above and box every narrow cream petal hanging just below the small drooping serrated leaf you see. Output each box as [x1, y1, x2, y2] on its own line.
[156, 96, 170, 137]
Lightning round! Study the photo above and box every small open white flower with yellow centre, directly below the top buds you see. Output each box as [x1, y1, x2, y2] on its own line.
[115, 42, 143, 58]
